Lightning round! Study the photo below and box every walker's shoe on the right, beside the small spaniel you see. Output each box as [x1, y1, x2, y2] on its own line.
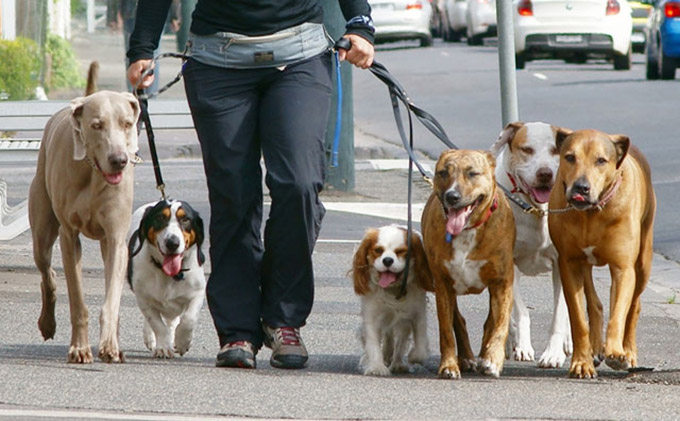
[262, 324, 309, 368]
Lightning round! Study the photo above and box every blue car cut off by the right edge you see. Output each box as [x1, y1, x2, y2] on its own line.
[645, 0, 680, 80]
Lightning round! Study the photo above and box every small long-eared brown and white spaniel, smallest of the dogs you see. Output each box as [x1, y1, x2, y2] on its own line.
[352, 225, 432, 376]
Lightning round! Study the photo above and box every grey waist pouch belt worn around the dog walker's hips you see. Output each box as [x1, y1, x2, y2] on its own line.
[188, 22, 330, 69]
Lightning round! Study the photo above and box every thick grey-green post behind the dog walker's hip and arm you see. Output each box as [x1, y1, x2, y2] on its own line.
[321, 0, 354, 191]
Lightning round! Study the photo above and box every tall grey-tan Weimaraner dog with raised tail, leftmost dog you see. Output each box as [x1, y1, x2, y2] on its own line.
[29, 64, 140, 363]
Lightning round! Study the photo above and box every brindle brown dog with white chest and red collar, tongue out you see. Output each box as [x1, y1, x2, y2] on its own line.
[421, 150, 515, 378]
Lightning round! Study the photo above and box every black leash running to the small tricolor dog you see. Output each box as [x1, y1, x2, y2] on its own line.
[134, 53, 187, 200]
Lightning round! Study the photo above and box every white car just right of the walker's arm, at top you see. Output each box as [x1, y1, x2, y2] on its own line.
[368, 0, 432, 47]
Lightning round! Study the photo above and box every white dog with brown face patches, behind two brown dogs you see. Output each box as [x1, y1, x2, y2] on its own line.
[491, 122, 572, 368]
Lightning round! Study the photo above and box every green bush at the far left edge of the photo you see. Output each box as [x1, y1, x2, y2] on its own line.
[0, 37, 40, 101]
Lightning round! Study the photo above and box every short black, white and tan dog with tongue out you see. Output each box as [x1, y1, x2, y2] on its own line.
[128, 200, 206, 358]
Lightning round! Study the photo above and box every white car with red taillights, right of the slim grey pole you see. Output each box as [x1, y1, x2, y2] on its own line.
[513, 0, 633, 70]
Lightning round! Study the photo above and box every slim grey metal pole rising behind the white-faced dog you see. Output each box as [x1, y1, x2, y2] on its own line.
[496, 0, 519, 127]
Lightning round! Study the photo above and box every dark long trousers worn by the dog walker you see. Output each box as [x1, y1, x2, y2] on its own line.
[184, 54, 331, 348]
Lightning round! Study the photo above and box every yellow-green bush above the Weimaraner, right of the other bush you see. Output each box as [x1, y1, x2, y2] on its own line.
[45, 34, 85, 92]
